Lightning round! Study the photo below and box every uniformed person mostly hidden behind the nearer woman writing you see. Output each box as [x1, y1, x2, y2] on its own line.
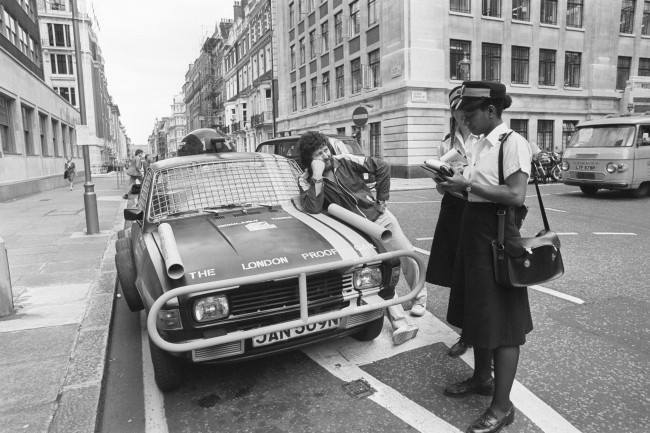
[422, 86, 479, 357]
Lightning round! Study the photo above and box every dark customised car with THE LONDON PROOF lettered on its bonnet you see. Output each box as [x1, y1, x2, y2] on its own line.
[115, 153, 424, 390]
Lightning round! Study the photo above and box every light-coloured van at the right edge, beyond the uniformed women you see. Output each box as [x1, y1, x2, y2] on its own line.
[562, 114, 650, 197]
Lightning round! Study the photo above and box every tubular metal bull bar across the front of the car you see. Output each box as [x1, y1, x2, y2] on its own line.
[147, 250, 425, 352]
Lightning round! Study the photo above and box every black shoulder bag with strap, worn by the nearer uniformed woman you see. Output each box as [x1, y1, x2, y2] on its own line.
[492, 133, 564, 287]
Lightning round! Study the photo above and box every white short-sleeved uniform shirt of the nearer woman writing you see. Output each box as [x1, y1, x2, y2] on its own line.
[463, 123, 532, 202]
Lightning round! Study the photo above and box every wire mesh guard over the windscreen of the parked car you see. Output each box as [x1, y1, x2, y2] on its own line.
[149, 157, 301, 221]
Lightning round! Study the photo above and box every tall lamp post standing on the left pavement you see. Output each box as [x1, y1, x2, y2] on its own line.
[70, 0, 99, 235]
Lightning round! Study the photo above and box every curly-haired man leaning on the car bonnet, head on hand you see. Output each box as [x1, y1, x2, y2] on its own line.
[298, 131, 426, 344]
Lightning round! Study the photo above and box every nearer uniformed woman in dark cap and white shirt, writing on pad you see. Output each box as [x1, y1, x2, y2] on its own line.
[439, 81, 533, 433]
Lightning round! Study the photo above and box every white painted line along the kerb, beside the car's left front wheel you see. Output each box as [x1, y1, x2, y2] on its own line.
[140, 311, 169, 433]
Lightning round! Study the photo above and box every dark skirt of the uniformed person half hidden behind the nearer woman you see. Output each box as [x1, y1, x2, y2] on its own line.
[426, 193, 465, 287]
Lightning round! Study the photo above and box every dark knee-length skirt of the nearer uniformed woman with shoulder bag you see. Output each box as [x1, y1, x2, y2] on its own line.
[447, 202, 533, 349]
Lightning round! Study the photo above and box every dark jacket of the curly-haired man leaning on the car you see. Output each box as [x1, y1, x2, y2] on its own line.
[300, 155, 390, 221]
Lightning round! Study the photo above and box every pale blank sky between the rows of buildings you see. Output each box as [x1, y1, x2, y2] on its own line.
[91, 0, 233, 145]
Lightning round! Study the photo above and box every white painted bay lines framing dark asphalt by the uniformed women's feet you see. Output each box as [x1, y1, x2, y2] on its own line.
[303, 311, 580, 433]
